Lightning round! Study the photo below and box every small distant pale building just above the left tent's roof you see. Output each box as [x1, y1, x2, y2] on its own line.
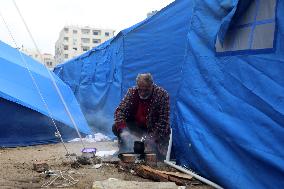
[20, 48, 55, 70]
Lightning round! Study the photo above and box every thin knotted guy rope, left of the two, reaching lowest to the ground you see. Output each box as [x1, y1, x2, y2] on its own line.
[0, 8, 72, 160]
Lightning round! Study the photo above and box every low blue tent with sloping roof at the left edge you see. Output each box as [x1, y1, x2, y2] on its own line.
[0, 41, 91, 147]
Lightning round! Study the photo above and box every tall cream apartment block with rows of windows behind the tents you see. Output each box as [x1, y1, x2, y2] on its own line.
[55, 26, 114, 64]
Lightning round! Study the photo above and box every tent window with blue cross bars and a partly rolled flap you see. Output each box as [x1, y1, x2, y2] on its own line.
[215, 0, 277, 55]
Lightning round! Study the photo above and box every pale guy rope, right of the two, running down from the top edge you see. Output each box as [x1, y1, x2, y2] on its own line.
[13, 0, 85, 148]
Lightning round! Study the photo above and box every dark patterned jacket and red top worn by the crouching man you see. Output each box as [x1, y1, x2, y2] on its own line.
[115, 84, 170, 140]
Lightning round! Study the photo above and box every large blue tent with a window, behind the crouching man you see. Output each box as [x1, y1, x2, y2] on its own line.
[55, 0, 284, 188]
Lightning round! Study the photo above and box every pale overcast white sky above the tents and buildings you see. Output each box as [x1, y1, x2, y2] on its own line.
[0, 0, 174, 54]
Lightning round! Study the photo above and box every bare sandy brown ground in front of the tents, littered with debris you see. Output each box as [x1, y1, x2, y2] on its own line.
[0, 142, 212, 189]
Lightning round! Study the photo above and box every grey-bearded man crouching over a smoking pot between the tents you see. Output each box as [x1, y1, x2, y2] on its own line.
[113, 73, 170, 159]
